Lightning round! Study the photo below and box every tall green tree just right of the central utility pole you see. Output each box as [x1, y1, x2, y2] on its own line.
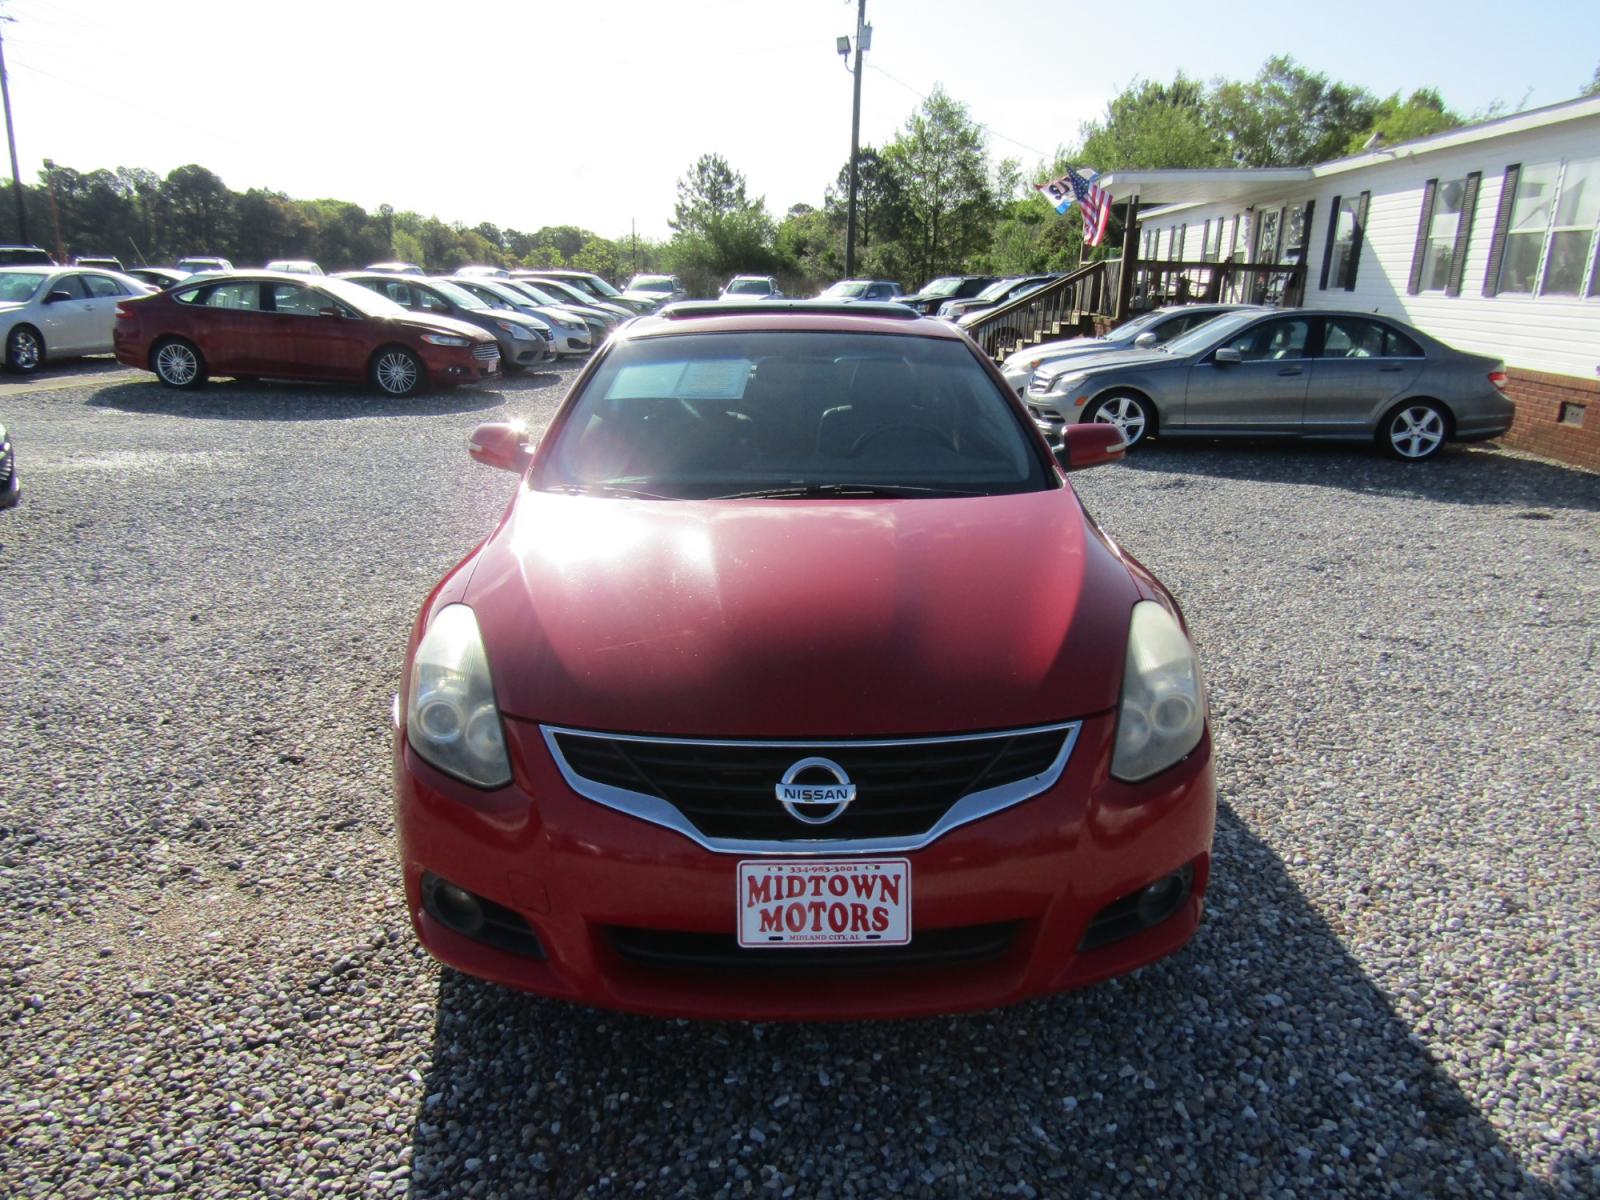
[883, 85, 997, 286]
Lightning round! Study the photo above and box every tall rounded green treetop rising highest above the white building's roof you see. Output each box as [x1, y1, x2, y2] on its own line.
[1208, 54, 1378, 166]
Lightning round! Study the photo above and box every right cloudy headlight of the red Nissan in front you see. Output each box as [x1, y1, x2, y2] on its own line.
[1110, 600, 1205, 782]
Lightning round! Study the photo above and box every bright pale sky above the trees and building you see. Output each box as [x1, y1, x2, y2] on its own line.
[0, 0, 1600, 238]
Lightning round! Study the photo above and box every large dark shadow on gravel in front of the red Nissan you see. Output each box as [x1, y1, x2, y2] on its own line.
[408, 806, 1574, 1198]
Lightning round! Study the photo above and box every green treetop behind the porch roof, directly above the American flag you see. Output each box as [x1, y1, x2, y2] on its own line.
[1075, 72, 1229, 171]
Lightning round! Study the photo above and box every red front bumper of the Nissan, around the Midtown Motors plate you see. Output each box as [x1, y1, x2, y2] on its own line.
[395, 714, 1216, 1019]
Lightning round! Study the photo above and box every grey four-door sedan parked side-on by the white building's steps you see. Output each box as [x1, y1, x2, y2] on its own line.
[1027, 309, 1514, 462]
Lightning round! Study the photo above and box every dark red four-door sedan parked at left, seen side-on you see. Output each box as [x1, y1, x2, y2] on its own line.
[112, 270, 499, 397]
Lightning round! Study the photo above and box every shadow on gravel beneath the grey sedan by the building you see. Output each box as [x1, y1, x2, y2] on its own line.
[1126, 438, 1600, 512]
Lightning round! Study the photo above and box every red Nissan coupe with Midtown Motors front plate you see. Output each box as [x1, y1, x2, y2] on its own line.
[394, 301, 1216, 1021]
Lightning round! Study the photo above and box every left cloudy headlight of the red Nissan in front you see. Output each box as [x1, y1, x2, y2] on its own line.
[405, 605, 510, 787]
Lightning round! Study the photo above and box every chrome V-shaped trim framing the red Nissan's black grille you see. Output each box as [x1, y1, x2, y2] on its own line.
[539, 722, 1083, 858]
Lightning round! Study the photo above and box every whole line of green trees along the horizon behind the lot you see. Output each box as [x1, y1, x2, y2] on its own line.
[0, 56, 1600, 294]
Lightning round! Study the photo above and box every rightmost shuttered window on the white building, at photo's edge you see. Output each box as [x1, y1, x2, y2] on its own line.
[1494, 160, 1600, 296]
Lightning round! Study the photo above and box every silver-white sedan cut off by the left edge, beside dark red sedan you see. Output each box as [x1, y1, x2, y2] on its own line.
[0, 267, 155, 374]
